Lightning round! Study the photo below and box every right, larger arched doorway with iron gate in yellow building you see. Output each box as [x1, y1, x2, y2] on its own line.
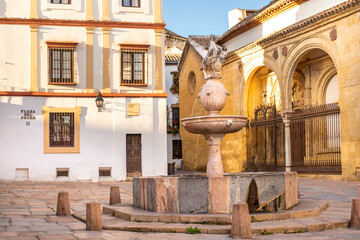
[288, 49, 341, 174]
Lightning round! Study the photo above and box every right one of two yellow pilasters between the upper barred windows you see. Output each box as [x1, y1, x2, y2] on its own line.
[102, 28, 111, 93]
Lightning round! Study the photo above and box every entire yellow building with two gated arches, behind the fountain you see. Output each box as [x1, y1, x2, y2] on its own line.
[179, 0, 360, 180]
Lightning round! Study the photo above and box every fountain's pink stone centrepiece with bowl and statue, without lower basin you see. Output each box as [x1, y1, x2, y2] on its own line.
[181, 36, 247, 177]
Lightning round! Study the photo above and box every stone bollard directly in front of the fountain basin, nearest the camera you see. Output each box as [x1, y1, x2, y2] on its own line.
[231, 203, 252, 238]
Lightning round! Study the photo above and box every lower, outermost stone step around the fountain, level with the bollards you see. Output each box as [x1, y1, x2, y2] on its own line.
[73, 209, 349, 235]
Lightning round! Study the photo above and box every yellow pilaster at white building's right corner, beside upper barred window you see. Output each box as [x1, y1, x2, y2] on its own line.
[154, 29, 164, 92]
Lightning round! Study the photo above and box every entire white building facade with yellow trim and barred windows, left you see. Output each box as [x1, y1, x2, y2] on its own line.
[0, 0, 167, 181]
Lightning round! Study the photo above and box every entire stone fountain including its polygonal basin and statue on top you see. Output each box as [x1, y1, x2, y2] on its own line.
[133, 39, 298, 214]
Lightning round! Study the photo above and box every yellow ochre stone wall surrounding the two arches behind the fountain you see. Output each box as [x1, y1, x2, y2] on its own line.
[180, 7, 360, 181]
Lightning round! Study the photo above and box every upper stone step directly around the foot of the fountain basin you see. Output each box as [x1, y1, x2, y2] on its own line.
[103, 200, 329, 225]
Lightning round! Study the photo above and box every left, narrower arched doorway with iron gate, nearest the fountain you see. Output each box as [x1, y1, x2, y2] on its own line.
[246, 66, 285, 171]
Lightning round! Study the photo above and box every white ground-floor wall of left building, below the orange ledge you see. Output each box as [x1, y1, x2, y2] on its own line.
[0, 97, 167, 181]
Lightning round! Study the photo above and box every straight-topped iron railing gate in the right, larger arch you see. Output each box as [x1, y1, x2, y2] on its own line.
[290, 103, 341, 174]
